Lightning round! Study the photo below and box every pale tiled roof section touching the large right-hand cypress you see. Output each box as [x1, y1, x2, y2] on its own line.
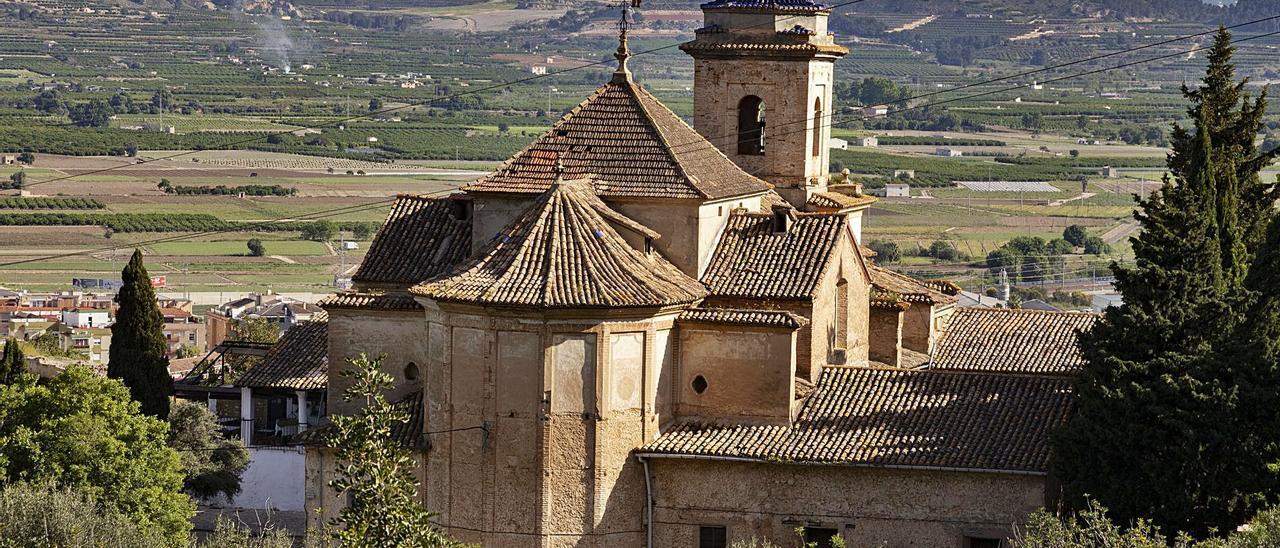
[931, 307, 1098, 374]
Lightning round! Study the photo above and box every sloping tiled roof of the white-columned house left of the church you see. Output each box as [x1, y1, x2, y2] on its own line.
[236, 320, 329, 391]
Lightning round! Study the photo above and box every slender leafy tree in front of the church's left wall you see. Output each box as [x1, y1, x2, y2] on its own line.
[328, 355, 460, 548]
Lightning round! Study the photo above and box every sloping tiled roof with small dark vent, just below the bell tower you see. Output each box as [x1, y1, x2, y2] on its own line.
[703, 210, 845, 298]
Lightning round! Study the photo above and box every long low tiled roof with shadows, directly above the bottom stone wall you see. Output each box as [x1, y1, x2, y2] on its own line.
[639, 366, 1071, 474]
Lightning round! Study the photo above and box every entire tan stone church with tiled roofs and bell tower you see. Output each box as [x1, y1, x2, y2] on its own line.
[293, 0, 1093, 548]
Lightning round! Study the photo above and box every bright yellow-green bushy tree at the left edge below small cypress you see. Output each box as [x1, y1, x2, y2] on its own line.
[0, 366, 195, 545]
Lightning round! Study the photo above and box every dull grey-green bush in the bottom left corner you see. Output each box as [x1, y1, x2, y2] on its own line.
[0, 483, 173, 548]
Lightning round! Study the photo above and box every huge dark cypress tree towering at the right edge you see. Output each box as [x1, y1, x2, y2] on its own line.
[1053, 26, 1280, 535]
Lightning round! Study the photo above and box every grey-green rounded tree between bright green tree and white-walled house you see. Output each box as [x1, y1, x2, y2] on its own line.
[169, 399, 248, 499]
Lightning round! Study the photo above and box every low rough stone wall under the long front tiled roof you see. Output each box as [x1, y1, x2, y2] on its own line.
[649, 458, 1046, 548]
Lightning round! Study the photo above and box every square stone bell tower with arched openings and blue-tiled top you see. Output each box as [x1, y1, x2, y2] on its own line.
[680, 0, 849, 207]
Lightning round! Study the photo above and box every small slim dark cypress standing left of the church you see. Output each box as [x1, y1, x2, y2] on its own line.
[106, 250, 173, 419]
